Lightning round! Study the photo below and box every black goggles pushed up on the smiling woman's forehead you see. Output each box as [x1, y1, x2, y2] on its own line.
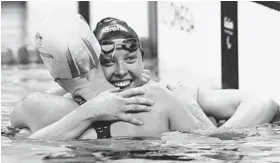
[99, 38, 141, 54]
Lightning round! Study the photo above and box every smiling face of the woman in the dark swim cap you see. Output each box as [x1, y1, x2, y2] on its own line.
[100, 39, 144, 90]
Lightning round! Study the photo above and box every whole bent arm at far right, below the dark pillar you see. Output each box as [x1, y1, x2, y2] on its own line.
[198, 89, 279, 129]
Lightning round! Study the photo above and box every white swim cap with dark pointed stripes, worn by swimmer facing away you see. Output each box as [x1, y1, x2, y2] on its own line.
[35, 12, 101, 79]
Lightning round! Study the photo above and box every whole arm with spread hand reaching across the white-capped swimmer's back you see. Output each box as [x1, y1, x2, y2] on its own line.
[30, 88, 153, 140]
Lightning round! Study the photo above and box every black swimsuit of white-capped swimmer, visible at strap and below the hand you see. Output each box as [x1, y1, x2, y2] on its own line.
[74, 96, 112, 139]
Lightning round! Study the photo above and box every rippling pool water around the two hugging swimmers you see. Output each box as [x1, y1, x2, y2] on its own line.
[1, 65, 280, 163]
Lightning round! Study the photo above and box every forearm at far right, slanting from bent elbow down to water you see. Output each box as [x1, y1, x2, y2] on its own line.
[219, 98, 279, 130]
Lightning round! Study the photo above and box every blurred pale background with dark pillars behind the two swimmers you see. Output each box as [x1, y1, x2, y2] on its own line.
[1, 1, 280, 102]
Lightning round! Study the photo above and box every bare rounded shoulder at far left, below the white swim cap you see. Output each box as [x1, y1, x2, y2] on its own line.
[11, 86, 70, 133]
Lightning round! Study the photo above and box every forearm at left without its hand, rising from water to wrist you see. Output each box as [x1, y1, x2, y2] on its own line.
[29, 105, 94, 140]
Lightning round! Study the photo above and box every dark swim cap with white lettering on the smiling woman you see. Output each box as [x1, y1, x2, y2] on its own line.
[93, 17, 144, 54]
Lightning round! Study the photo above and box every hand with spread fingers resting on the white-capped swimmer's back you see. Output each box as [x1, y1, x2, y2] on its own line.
[83, 87, 154, 125]
